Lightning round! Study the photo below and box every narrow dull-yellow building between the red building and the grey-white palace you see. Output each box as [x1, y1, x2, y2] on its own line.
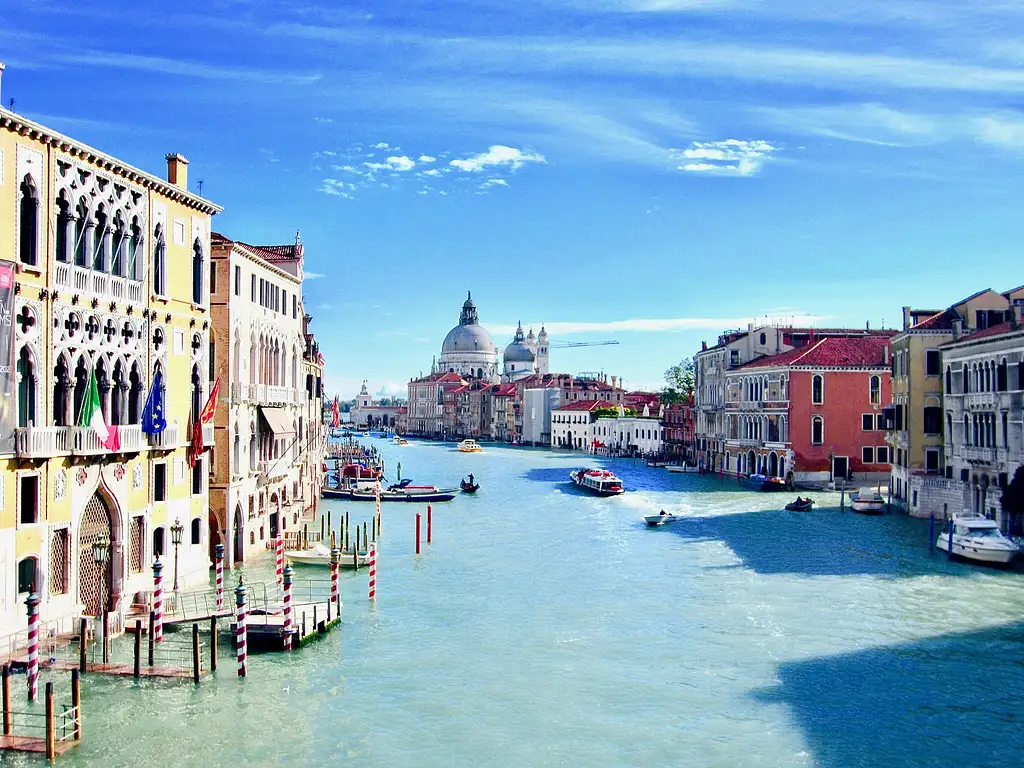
[887, 289, 1024, 515]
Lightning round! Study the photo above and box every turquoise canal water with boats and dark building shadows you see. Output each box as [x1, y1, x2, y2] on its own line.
[19, 440, 1024, 768]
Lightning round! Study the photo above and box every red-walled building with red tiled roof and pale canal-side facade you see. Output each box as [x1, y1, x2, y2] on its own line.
[725, 334, 892, 482]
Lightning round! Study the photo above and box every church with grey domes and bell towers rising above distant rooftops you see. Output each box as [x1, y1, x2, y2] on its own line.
[432, 293, 548, 382]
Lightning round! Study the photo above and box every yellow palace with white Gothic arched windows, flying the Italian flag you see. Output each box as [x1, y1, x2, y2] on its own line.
[0, 99, 221, 634]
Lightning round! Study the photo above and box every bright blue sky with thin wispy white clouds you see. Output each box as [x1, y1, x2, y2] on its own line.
[0, 0, 1024, 396]
